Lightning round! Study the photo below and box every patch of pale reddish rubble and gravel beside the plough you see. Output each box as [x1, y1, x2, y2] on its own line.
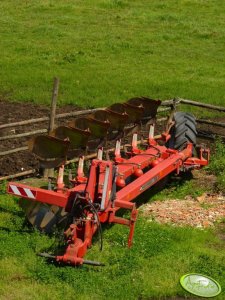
[142, 193, 225, 228]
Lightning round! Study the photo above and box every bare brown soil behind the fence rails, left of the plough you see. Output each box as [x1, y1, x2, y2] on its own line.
[0, 100, 80, 176]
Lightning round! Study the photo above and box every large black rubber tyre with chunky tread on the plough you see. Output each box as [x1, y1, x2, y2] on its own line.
[166, 112, 197, 150]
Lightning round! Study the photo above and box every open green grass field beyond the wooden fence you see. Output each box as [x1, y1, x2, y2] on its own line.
[0, 0, 225, 107]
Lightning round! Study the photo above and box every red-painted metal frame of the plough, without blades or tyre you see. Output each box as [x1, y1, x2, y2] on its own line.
[5, 135, 209, 265]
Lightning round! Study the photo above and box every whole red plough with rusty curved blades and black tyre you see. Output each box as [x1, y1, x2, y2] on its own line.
[7, 98, 209, 266]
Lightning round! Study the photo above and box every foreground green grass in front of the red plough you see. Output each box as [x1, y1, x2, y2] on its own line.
[0, 178, 225, 300]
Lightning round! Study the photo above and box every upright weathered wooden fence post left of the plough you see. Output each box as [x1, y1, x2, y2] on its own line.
[43, 77, 59, 178]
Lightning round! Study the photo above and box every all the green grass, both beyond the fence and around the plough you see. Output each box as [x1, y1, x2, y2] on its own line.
[0, 0, 225, 300]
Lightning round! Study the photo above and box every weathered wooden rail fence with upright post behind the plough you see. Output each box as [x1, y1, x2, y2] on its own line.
[0, 92, 225, 181]
